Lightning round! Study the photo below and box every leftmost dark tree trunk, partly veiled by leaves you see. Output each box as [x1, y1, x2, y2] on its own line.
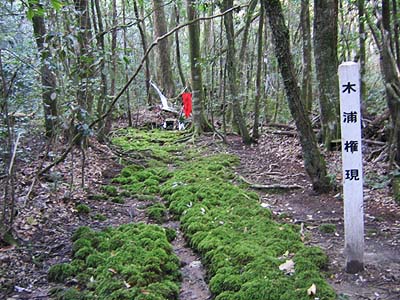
[31, 4, 58, 138]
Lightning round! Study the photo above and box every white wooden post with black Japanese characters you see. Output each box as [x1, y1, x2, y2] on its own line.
[339, 62, 364, 274]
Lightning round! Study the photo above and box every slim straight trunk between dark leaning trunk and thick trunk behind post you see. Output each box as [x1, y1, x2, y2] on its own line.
[300, 0, 313, 114]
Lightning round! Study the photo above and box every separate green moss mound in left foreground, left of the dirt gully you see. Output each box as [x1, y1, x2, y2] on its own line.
[48, 223, 180, 300]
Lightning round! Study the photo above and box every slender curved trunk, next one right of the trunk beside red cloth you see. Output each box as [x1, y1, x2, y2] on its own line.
[222, 0, 253, 144]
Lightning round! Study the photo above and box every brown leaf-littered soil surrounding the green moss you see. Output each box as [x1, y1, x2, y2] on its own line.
[0, 123, 400, 300]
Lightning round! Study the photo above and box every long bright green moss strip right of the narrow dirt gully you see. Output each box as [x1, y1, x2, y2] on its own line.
[161, 154, 336, 300]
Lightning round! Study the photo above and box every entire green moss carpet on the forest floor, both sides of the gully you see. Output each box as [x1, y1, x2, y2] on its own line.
[49, 130, 336, 300]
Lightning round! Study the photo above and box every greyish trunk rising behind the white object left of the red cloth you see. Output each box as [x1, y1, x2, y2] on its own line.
[152, 0, 175, 97]
